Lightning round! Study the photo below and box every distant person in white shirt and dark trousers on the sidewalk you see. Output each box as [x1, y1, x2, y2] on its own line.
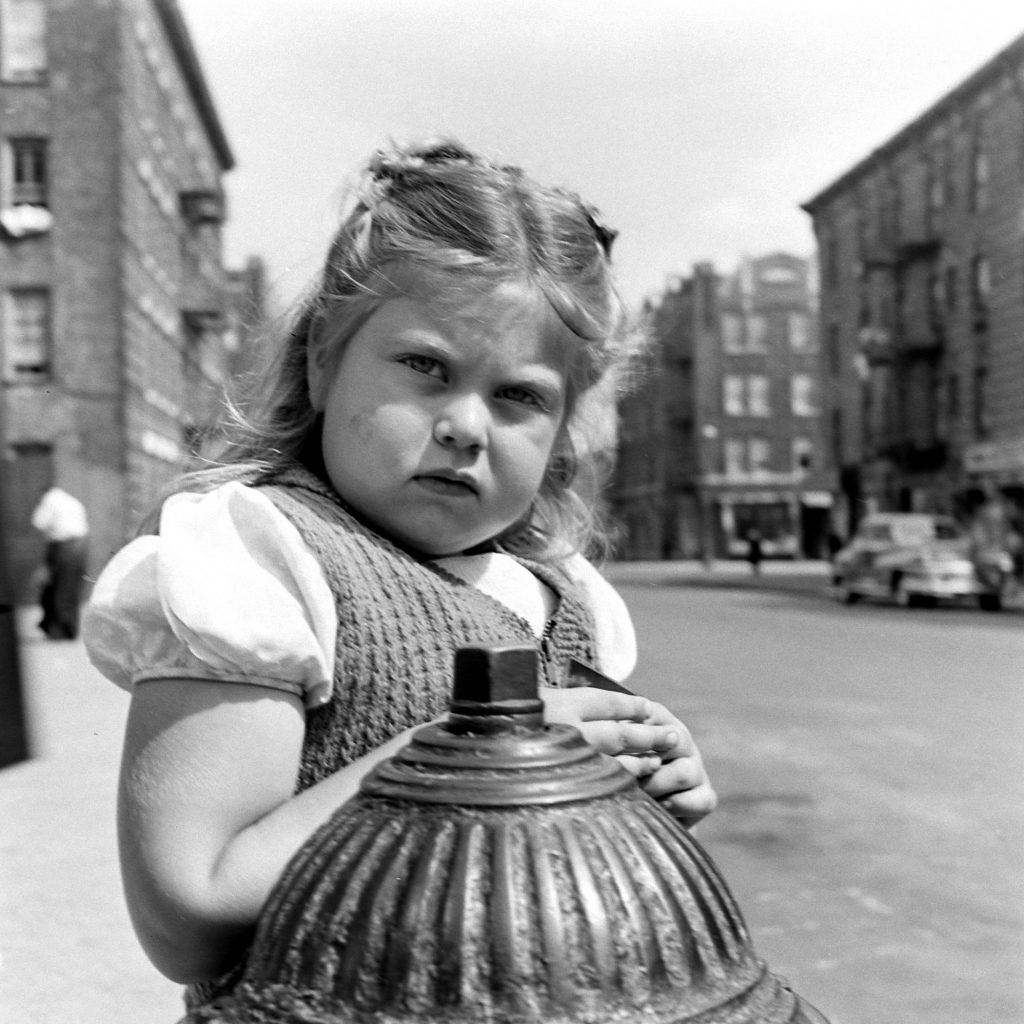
[32, 487, 89, 640]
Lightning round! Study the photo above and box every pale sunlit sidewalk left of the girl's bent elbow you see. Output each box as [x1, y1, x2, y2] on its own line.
[0, 608, 183, 1024]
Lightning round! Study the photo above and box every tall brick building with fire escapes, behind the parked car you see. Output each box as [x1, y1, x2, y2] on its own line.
[804, 36, 1024, 526]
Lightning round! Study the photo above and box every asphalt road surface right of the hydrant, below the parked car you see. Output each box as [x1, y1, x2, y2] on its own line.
[620, 577, 1024, 1024]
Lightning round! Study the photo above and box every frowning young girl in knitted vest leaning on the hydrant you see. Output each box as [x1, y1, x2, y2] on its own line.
[85, 142, 715, 1008]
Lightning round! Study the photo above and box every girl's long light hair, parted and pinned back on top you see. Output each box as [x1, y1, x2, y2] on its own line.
[178, 139, 645, 560]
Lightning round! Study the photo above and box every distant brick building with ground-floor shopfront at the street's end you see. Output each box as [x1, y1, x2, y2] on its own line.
[611, 253, 835, 558]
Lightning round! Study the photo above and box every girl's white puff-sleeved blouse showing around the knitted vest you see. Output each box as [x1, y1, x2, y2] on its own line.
[82, 482, 636, 707]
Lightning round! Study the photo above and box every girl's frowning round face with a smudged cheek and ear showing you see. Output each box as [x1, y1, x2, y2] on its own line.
[309, 284, 567, 557]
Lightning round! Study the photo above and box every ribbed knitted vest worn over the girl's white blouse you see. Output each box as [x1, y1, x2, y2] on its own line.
[261, 467, 595, 791]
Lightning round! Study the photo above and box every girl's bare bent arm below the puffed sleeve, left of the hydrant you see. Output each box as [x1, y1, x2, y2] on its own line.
[118, 679, 415, 983]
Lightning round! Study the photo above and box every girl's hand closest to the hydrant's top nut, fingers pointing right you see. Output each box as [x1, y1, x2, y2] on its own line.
[541, 686, 689, 778]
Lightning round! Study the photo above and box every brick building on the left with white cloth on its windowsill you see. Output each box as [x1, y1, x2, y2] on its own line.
[0, 0, 233, 599]
